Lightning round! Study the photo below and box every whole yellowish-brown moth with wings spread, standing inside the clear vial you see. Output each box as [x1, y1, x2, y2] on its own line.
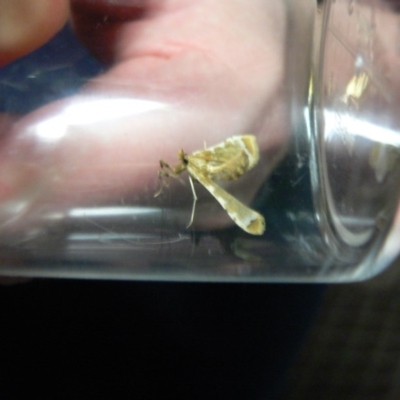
[155, 135, 265, 235]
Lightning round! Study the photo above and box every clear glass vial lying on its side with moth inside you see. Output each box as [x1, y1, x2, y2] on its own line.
[0, 0, 400, 282]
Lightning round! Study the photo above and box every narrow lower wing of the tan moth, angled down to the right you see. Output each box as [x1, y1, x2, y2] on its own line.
[188, 166, 265, 235]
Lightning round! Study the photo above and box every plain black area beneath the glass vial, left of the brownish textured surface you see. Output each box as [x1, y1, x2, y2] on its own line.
[0, 279, 321, 400]
